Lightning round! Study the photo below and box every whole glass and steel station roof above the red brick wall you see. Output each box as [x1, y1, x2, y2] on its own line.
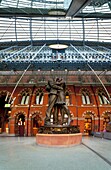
[0, 0, 111, 84]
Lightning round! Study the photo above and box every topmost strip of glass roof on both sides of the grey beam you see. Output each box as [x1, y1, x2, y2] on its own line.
[0, 0, 111, 18]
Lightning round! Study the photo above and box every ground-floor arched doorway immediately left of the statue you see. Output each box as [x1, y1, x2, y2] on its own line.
[31, 112, 42, 136]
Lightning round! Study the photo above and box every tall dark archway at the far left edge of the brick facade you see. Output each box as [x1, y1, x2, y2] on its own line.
[0, 92, 11, 133]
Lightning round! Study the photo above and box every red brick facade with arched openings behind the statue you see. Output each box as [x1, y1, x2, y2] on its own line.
[0, 85, 111, 136]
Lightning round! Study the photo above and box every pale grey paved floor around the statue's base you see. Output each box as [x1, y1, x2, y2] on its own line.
[0, 137, 111, 170]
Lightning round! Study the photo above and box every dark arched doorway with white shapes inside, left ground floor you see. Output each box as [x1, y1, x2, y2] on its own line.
[15, 113, 25, 136]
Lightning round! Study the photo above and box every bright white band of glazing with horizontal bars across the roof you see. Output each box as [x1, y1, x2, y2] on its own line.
[0, 17, 111, 42]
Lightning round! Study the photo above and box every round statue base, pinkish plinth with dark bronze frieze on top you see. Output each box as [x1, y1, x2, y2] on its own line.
[36, 125, 82, 147]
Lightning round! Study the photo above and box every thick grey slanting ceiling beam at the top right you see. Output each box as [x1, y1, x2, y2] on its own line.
[66, 0, 91, 17]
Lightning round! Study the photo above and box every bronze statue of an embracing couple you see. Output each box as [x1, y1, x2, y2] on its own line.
[45, 78, 70, 125]
